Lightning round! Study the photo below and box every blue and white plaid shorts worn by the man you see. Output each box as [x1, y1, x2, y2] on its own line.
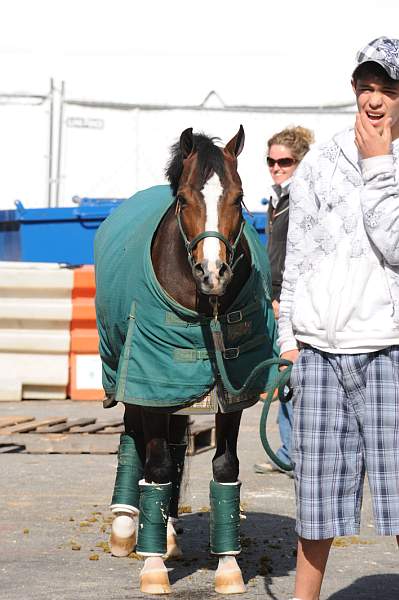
[291, 346, 399, 540]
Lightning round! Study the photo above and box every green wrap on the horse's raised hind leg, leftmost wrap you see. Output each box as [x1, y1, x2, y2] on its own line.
[111, 433, 143, 508]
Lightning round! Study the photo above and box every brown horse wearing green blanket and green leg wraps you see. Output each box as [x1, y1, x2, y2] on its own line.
[95, 126, 284, 594]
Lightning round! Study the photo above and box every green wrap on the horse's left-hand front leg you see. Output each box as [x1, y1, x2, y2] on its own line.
[136, 481, 172, 556]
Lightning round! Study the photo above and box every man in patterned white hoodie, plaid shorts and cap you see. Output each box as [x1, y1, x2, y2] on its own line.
[279, 38, 399, 600]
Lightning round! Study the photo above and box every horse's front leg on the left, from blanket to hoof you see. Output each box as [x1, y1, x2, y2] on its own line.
[136, 409, 173, 594]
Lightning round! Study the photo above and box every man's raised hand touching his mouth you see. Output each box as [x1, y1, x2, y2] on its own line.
[355, 113, 392, 158]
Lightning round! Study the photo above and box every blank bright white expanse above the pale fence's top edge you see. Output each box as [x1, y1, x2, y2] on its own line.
[0, 0, 399, 106]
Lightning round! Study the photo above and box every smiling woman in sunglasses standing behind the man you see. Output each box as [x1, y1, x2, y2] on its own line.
[255, 127, 314, 476]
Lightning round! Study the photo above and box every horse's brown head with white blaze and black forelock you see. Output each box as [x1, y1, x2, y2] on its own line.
[166, 125, 244, 296]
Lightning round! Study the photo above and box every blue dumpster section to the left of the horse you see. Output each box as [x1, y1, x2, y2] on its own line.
[0, 198, 123, 265]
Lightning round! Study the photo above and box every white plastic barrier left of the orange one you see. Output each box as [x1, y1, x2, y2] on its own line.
[0, 262, 73, 400]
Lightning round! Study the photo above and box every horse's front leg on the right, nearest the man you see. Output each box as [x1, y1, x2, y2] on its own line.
[210, 411, 245, 594]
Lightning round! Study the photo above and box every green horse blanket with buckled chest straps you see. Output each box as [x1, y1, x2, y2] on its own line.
[94, 185, 279, 409]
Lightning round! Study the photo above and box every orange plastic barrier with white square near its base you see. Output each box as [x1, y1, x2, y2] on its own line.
[68, 265, 104, 400]
